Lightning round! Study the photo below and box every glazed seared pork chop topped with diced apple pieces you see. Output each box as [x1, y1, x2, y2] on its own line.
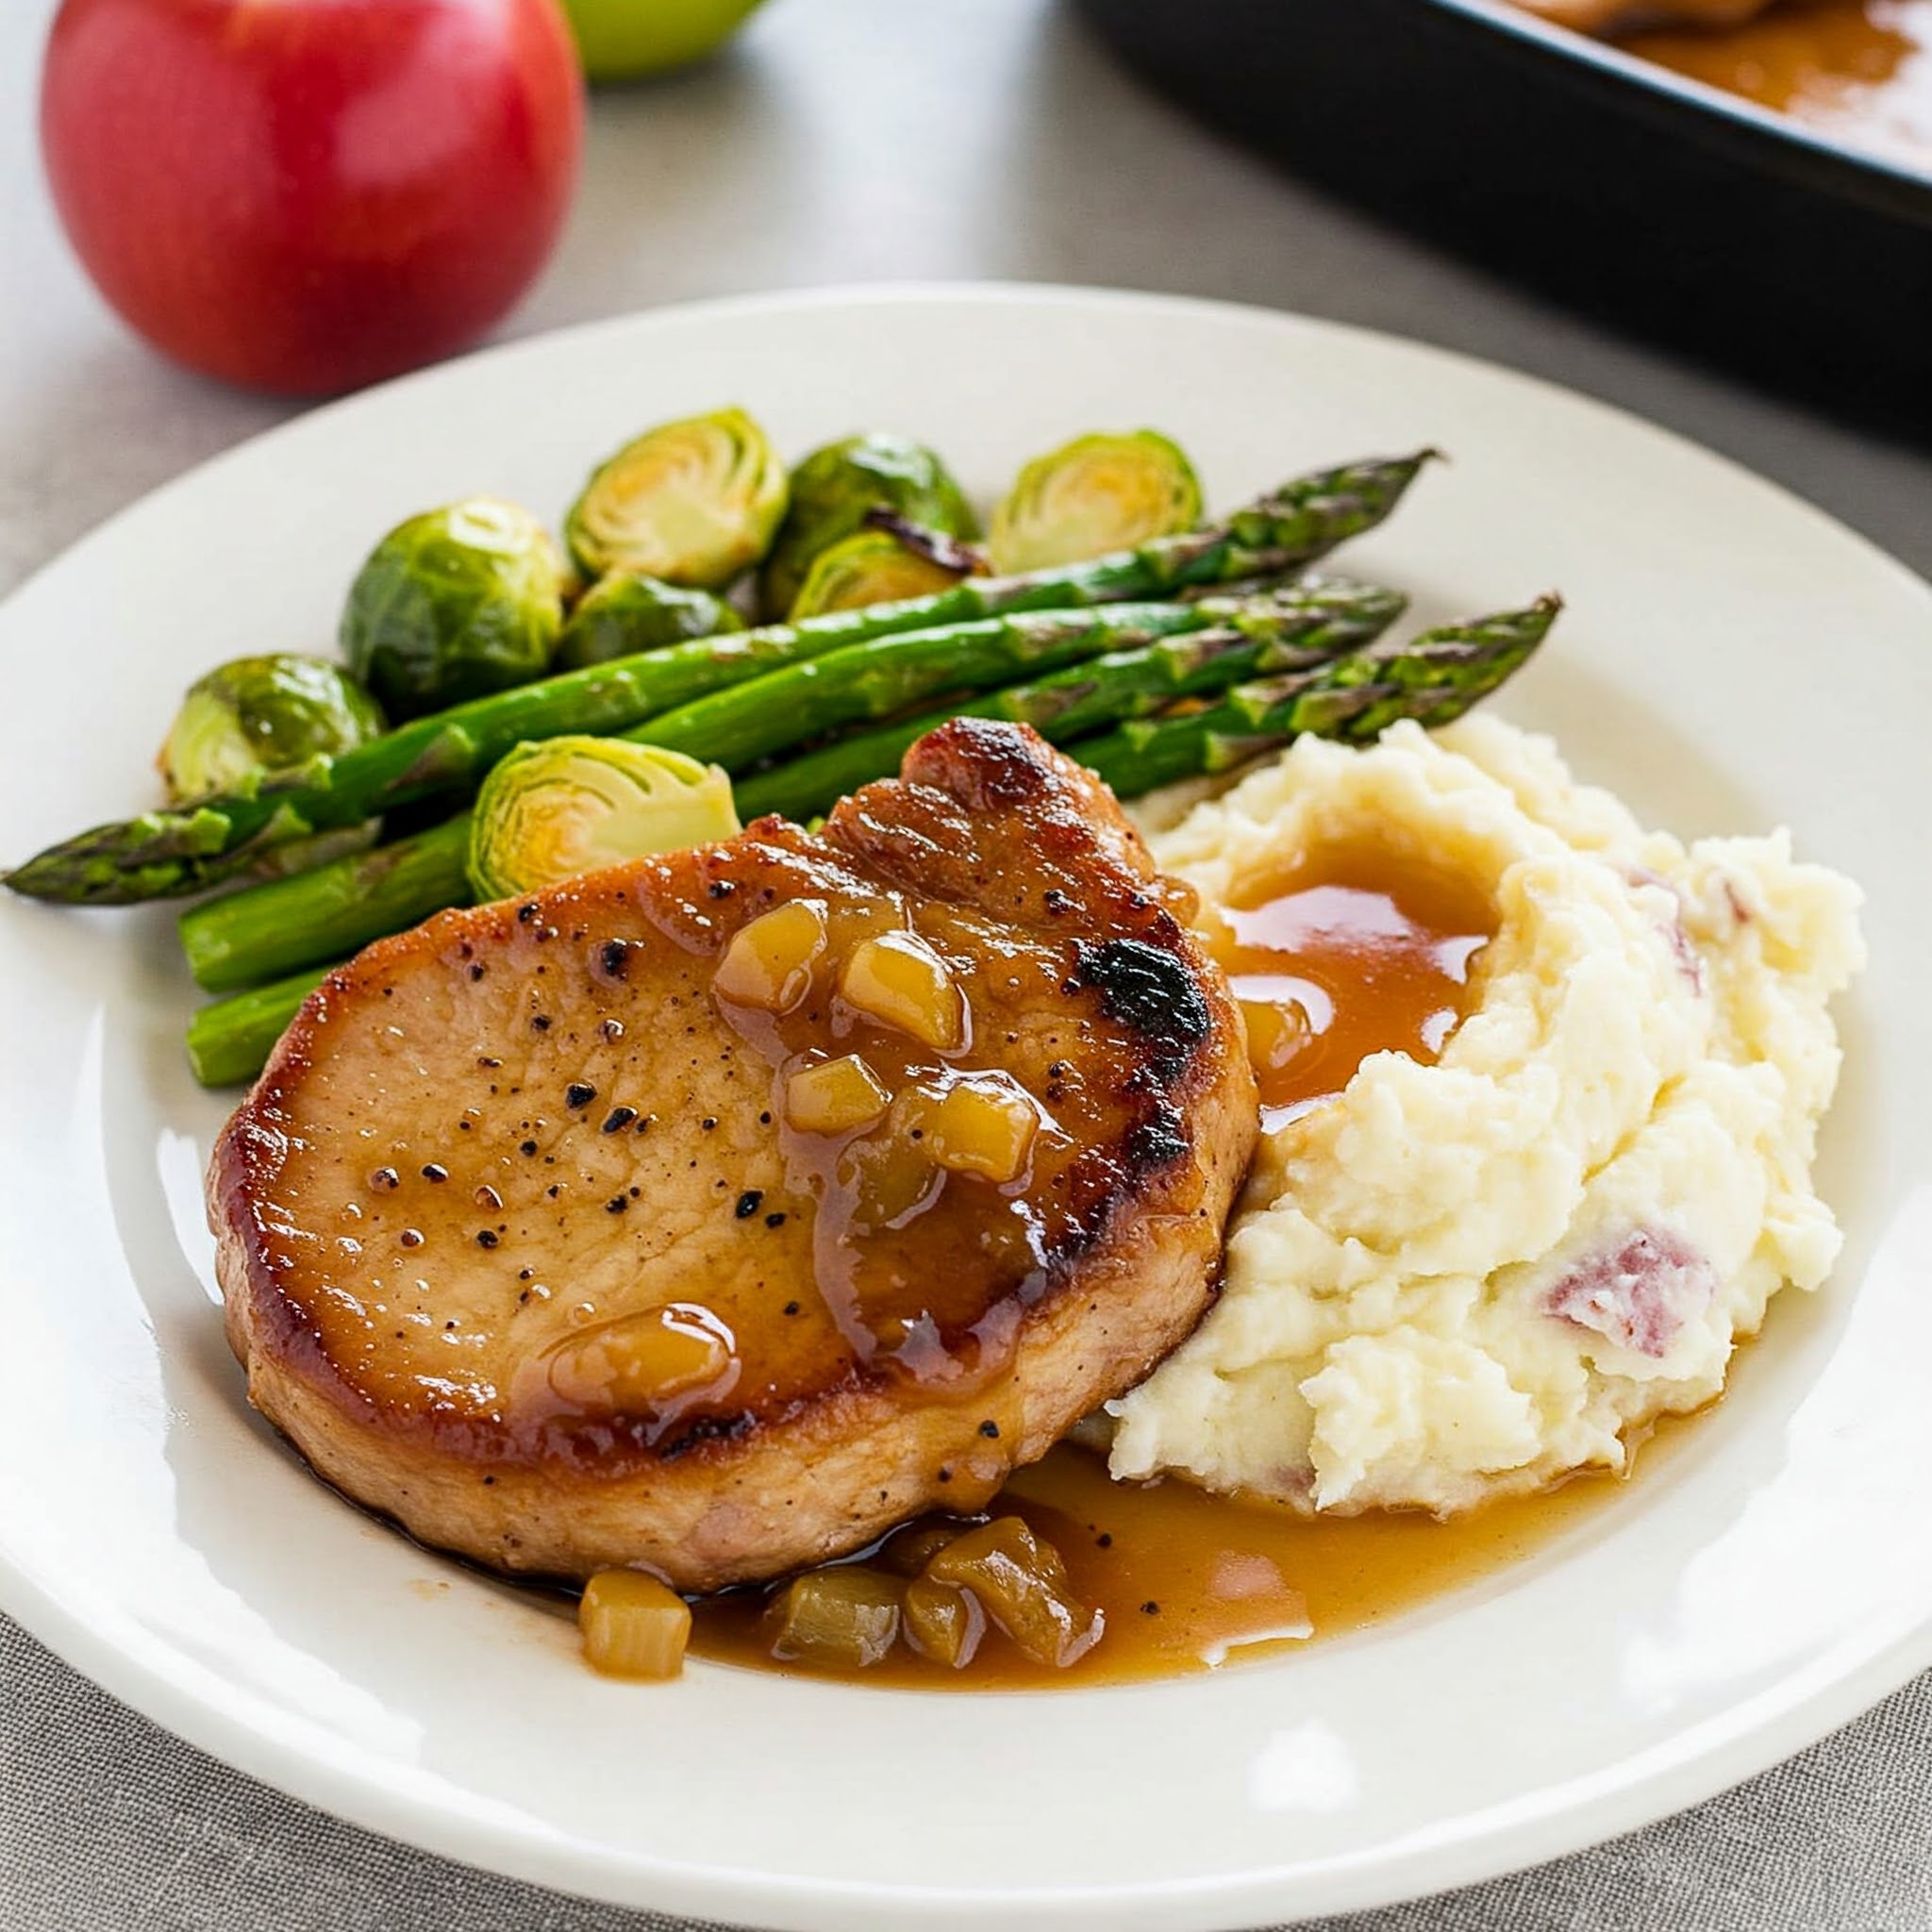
[208, 721, 1256, 1591]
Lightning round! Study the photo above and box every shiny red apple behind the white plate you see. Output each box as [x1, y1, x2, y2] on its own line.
[41, 0, 583, 396]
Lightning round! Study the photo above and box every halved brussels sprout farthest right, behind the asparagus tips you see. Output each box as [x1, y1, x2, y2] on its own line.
[990, 429, 1202, 572]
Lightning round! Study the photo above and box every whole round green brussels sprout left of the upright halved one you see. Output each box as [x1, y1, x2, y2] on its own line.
[341, 496, 564, 719]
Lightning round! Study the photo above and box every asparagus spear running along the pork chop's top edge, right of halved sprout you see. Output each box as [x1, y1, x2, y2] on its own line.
[736, 579, 1407, 819]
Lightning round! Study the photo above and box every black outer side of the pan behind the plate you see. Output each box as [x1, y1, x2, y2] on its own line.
[1076, 0, 1932, 441]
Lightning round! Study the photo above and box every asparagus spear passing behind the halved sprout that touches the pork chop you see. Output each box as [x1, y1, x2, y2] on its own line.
[177, 581, 1401, 993]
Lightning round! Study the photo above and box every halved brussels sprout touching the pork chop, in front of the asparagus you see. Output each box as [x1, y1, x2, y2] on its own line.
[470, 736, 738, 898]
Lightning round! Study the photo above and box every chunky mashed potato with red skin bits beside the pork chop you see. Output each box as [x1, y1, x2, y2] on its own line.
[1111, 719, 1862, 1513]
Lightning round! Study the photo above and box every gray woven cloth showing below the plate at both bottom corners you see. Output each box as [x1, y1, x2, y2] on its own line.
[0, 1619, 1932, 1932]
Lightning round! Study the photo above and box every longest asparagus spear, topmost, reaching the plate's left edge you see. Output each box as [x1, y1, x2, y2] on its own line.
[4, 452, 1432, 904]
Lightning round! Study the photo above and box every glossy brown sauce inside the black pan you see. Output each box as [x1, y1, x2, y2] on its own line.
[1621, 0, 1932, 166]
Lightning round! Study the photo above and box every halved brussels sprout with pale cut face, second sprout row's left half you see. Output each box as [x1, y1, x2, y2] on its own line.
[564, 409, 787, 591]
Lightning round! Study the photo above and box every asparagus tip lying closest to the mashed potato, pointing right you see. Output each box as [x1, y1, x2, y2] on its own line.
[1066, 597, 1563, 798]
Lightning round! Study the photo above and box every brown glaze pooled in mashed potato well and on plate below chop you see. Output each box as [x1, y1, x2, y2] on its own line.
[668, 848, 1661, 1689]
